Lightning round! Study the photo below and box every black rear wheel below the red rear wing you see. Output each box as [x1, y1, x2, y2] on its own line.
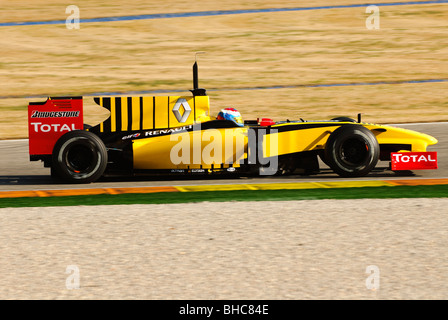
[52, 130, 107, 183]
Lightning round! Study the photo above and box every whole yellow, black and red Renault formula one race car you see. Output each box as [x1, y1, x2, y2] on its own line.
[28, 63, 437, 183]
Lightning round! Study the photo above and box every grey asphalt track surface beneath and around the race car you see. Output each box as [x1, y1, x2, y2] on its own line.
[0, 122, 448, 191]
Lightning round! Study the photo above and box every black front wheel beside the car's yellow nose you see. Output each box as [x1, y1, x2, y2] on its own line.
[325, 124, 380, 177]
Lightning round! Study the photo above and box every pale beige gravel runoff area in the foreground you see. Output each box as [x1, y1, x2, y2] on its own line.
[0, 198, 448, 300]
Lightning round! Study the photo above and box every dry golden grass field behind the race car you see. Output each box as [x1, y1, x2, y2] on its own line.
[0, 0, 448, 139]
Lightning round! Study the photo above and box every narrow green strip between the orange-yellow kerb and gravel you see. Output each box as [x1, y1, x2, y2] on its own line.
[0, 185, 448, 208]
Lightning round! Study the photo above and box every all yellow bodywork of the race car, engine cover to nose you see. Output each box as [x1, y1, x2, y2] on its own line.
[91, 96, 437, 170]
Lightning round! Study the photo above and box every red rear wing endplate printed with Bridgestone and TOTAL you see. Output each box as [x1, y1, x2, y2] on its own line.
[28, 97, 84, 160]
